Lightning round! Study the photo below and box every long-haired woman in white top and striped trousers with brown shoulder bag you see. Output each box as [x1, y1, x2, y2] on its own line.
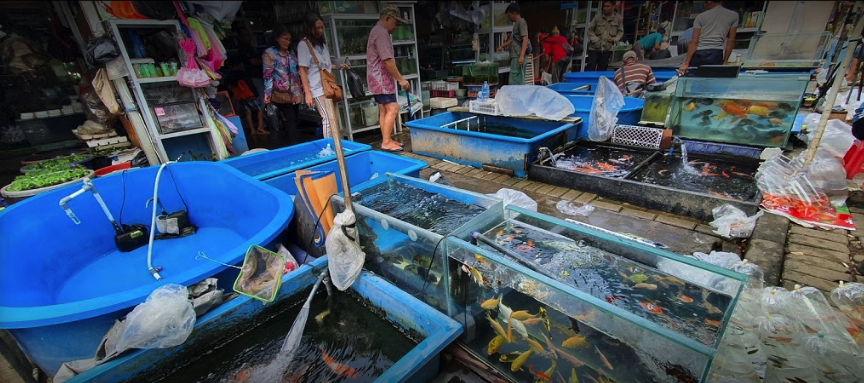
[297, 12, 348, 137]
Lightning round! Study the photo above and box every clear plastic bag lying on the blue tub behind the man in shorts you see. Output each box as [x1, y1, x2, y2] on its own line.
[495, 85, 576, 121]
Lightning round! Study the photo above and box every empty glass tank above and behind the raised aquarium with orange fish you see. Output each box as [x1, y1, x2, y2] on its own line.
[742, 32, 831, 69]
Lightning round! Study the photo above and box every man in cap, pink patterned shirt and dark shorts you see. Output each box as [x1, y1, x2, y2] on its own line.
[366, 5, 410, 152]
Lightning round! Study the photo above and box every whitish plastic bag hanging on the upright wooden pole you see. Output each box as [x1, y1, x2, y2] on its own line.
[324, 210, 366, 291]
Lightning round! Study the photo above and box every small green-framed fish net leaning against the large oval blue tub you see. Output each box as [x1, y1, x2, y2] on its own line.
[234, 245, 285, 302]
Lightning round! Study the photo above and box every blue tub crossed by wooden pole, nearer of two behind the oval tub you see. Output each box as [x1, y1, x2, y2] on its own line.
[264, 150, 426, 195]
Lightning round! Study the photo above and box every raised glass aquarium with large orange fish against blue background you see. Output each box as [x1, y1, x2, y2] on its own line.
[669, 73, 810, 147]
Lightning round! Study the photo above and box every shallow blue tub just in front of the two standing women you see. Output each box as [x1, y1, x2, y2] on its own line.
[222, 138, 372, 180]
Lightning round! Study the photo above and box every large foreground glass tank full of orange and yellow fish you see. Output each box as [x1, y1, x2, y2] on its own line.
[447, 207, 746, 382]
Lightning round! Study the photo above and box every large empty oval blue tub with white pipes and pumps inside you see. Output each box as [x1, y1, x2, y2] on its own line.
[0, 162, 294, 376]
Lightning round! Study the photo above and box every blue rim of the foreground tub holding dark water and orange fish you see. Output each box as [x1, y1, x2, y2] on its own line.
[67, 257, 462, 383]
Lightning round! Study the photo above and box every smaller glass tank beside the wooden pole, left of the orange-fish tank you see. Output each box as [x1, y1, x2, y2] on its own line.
[332, 173, 503, 313]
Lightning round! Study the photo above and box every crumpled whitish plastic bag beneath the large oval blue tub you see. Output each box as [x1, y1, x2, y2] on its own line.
[114, 284, 195, 352]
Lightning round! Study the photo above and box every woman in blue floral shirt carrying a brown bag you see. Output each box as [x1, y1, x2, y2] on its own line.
[261, 26, 303, 145]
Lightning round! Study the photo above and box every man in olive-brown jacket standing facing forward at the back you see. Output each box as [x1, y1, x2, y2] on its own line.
[585, 1, 624, 71]
